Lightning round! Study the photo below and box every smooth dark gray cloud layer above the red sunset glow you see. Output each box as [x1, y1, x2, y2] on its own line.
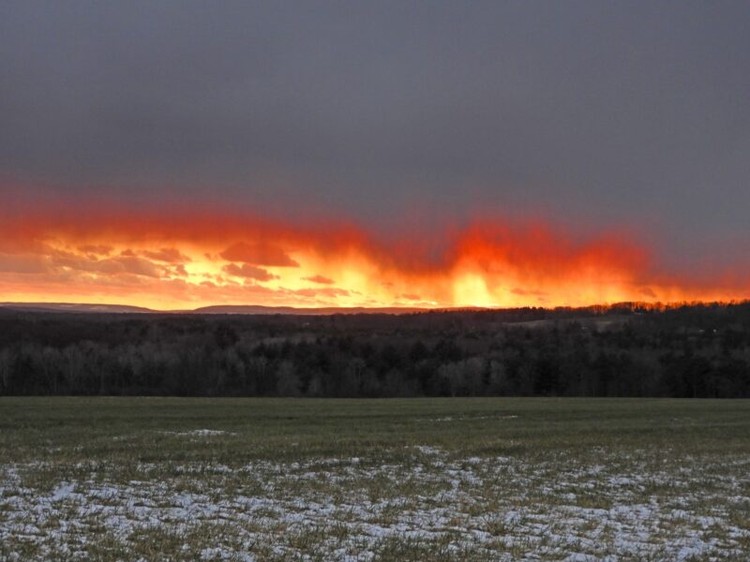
[0, 0, 750, 258]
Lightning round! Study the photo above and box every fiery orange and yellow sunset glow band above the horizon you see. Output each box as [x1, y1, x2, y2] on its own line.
[0, 191, 747, 310]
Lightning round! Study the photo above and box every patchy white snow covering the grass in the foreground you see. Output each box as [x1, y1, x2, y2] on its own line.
[0, 450, 750, 562]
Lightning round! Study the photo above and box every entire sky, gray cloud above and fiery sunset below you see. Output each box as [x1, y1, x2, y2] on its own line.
[0, 0, 750, 310]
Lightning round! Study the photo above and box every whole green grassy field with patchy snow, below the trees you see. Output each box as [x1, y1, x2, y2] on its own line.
[0, 398, 750, 561]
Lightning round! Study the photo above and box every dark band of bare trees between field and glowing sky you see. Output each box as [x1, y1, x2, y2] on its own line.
[0, 303, 750, 398]
